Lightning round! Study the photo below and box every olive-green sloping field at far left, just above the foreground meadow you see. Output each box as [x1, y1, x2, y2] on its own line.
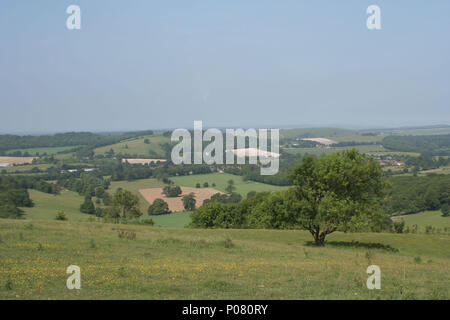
[22, 189, 90, 221]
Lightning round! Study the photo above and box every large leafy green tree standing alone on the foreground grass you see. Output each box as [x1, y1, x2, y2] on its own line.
[288, 149, 388, 246]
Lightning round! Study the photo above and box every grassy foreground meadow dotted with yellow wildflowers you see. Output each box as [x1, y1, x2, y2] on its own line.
[0, 220, 450, 299]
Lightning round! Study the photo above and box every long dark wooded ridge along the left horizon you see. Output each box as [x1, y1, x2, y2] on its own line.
[0, 130, 153, 152]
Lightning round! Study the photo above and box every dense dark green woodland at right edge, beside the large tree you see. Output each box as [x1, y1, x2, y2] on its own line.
[384, 174, 450, 214]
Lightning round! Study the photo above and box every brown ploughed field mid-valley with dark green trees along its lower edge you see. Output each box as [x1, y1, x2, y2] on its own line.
[139, 187, 223, 212]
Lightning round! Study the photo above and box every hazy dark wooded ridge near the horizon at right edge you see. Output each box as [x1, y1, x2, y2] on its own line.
[382, 134, 450, 155]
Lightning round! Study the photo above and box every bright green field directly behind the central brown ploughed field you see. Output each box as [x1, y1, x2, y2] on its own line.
[170, 173, 286, 198]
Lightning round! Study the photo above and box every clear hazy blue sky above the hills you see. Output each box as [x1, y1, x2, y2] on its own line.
[0, 0, 450, 133]
